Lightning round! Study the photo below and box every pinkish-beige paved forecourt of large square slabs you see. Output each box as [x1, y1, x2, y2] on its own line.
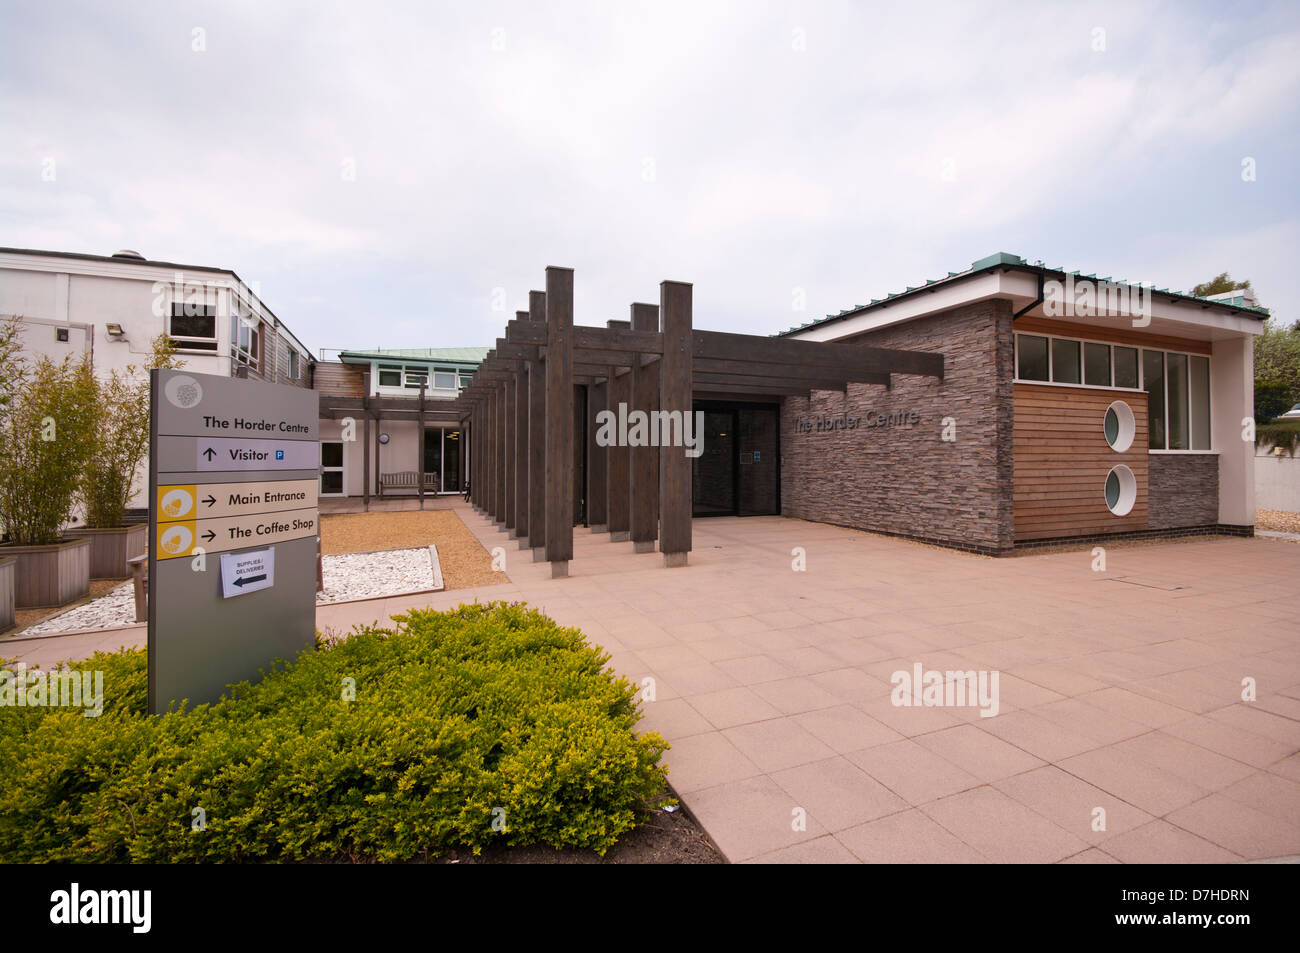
[10, 501, 1300, 863]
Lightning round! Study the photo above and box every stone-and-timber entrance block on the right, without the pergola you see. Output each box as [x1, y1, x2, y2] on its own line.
[780, 252, 1268, 554]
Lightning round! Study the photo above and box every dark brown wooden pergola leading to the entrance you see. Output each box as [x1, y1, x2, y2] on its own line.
[449, 267, 944, 576]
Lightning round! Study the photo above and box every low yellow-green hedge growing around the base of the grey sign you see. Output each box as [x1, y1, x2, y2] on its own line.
[0, 603, 668, 863]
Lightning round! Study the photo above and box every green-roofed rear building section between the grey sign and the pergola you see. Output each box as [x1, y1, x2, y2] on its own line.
[315, 347, 488, 502]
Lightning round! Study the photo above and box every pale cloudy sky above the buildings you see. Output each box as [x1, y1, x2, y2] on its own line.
[0, 0, 1300, 356]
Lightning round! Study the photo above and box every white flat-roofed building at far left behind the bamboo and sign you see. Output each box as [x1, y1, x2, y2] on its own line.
[0, 248, 315, 508]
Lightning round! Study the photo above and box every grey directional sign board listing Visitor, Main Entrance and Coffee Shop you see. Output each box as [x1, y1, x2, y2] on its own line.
[148, 371, 320, 714]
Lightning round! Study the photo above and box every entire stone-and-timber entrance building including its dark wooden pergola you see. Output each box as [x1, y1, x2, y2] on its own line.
[456, 252, 1268, 575]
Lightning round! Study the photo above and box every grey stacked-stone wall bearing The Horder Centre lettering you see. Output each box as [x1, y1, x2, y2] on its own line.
[781, 300, 1014, 553]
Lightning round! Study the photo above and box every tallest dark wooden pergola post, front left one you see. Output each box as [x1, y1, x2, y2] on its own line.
[543, 265, 573, 579]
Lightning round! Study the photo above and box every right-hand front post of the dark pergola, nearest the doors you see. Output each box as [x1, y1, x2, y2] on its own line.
[659, 281, 703, 566]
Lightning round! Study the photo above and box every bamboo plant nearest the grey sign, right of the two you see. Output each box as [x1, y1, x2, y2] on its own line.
[81, 334, 181, 529]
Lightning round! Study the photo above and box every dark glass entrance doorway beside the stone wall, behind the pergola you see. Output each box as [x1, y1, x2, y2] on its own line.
[692, 400, 781, 516]
